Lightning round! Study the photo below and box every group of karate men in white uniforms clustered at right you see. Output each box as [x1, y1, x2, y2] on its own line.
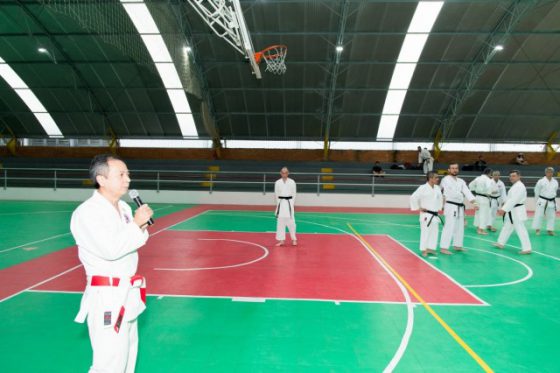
[410, 163, 558, 256]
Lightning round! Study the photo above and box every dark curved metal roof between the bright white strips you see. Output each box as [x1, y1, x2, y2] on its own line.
[0, 0, 560, 142]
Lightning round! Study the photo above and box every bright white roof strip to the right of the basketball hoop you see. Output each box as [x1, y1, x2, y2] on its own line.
[377, 1, 443, 140]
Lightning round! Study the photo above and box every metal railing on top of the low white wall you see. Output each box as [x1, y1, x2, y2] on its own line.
[0, 168, 542, 196]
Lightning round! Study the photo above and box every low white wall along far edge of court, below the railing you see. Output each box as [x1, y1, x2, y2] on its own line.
[0, 188, 535, 211]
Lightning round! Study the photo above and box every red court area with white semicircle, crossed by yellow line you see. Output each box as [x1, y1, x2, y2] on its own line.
[36, 231, 482, 304]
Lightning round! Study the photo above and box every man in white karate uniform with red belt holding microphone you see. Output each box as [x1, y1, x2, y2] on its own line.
[70, 154, 153, 373]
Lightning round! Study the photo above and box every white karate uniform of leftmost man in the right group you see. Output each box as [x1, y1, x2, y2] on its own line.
[410, 183, 443, 251]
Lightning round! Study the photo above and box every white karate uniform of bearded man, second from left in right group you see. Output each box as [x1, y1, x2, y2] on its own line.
[439, 175, 475, 249]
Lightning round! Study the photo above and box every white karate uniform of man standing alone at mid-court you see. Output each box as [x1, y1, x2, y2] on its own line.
[274, 178, 297, 241]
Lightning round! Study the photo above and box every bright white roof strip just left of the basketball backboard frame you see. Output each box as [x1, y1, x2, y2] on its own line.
[120, 0, 198, 137]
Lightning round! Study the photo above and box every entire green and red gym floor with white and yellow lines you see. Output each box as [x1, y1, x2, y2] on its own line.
[0, 201, 560, 373]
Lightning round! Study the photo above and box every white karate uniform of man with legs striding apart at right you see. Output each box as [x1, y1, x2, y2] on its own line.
[498, 181, 531, 251]
